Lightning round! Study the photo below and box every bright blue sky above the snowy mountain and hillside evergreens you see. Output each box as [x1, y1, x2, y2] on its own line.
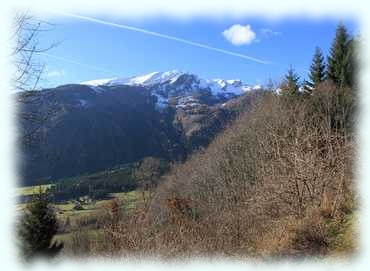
[38, 13, 357, 87]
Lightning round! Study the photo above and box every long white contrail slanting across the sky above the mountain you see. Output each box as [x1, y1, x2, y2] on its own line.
[47, 9, 274, 64]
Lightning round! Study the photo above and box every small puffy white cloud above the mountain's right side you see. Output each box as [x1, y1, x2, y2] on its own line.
[222, 24, 256, 46]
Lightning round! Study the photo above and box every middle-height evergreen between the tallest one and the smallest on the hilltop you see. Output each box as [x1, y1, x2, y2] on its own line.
[305, 47, 326, 92]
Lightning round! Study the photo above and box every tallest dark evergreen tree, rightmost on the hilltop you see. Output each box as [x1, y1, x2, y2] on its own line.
[328, 23, 353, 88]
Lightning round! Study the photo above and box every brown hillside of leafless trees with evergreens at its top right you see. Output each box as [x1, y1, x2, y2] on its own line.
[66, 24, 356, 257]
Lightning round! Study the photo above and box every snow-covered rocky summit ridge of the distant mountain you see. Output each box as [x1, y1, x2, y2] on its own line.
[81, 70, 261, 108]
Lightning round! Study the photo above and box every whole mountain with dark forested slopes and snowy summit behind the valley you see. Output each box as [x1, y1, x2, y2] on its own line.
[17, 70, 261, 185]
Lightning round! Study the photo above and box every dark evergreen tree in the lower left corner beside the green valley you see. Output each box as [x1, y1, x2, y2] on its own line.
[18, 187, 63, 260]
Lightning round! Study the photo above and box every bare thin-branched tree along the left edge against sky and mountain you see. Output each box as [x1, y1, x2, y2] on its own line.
[13, 11, 58, 147]
